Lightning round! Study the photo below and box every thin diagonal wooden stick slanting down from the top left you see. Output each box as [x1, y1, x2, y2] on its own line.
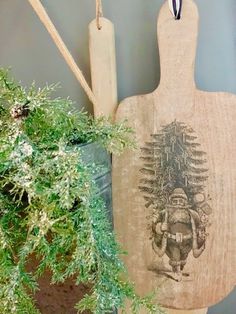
[28, 0, 100, 113]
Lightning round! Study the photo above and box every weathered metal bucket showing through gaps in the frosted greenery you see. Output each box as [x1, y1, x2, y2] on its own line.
[35, 143, 112, 314]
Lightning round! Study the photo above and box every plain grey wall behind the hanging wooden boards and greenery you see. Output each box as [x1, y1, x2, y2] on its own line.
[0, 0, 236, 314]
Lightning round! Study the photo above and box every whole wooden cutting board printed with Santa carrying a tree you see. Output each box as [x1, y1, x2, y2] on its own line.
[113, 0, 236, 310]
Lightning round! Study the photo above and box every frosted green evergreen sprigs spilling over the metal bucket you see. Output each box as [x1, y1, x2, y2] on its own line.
[0, 69, 161, 314]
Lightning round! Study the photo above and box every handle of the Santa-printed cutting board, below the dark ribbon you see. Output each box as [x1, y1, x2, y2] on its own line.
[157, 0, 198, 93]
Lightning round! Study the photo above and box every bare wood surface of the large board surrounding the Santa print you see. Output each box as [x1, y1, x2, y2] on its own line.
[113, 0, 236, 310]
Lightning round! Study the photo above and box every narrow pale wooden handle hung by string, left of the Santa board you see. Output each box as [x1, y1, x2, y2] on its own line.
[89, 17, 118, 117]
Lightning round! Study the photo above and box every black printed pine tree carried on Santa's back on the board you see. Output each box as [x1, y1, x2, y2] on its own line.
[139, 121, 208, 210]
